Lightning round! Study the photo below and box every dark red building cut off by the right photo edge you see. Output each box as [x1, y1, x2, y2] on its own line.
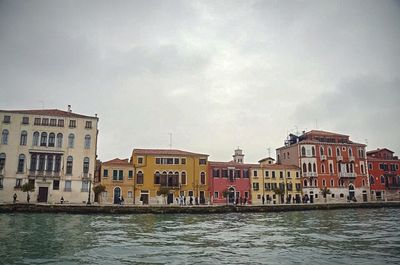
[367, 148, 400, 200]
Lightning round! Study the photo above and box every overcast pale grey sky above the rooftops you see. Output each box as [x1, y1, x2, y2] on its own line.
[0, 0, 400, 162]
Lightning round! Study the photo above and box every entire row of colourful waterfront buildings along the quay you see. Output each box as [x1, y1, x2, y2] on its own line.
[0, 107, 400, 205]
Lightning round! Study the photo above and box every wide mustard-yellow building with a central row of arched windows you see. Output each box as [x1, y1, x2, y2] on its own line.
[131, 149, 209, 205]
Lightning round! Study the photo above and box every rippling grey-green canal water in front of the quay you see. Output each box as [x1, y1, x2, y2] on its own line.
[0, 208, 400, 264]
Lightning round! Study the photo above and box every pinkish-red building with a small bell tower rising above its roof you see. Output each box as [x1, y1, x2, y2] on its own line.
[209, 149, 254, 204]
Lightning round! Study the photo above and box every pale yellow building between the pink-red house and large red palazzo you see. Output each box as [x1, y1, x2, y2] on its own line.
[250, 157, 301, 204]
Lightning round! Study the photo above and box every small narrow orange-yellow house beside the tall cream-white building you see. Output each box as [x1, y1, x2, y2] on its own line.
[100, 158, 135, 205]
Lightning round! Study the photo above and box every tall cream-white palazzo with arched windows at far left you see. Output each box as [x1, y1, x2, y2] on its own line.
[0, 106, 98, 203]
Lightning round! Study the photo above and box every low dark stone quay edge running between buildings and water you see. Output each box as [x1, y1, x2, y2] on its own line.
[0, 201, 400, 214]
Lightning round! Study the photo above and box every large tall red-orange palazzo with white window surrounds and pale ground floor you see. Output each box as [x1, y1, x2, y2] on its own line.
[276, 130, 369, 203]
